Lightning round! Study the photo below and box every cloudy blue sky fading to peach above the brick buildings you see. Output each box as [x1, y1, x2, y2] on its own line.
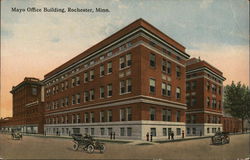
[0, 0, 249, 117]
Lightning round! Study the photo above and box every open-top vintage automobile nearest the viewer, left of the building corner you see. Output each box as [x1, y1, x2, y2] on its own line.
[71, 134, 105, 153]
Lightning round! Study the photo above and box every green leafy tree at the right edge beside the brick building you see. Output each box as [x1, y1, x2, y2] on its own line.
[224, 82, 250, 132]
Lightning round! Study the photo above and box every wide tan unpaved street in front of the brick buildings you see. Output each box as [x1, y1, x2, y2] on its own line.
[0, 134, 250, 160]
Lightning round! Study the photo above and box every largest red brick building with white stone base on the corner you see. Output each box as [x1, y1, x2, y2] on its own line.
[43, 19, 189, 139]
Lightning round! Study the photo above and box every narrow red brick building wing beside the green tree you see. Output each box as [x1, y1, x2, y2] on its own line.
[186, 58, 225, 135]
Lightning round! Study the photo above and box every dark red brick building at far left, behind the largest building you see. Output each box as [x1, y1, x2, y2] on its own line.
[1, 77, 44, 133]
